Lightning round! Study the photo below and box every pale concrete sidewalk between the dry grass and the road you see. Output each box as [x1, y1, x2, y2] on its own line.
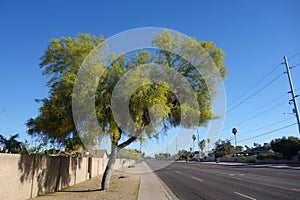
[126, 162, 178, 200]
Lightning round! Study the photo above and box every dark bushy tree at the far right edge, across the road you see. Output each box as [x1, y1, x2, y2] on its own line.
[271, 136, 300, 159]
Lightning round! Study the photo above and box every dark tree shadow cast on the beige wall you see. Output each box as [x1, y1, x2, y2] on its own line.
[18, 155, 83, 198]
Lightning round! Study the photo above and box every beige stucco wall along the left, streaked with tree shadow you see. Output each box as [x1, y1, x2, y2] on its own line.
[0, 153, 107, 200]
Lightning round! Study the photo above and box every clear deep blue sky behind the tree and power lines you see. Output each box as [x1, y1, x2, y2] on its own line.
[0, 0, 300, 153]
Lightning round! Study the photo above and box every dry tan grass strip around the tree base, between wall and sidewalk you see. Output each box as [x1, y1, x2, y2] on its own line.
[35, 171, 140, 200]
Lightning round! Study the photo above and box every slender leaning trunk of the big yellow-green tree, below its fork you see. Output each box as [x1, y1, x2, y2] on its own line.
[101, 144, 118, 190]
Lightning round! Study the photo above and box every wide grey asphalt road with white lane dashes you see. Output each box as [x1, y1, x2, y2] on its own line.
[147, 161, 300, 200]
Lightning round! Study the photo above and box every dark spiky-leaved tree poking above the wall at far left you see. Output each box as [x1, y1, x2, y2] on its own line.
[0, 134, 23, 153]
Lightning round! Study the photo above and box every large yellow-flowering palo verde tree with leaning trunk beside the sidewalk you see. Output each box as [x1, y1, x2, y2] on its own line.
[27, 31, 227, 189]
